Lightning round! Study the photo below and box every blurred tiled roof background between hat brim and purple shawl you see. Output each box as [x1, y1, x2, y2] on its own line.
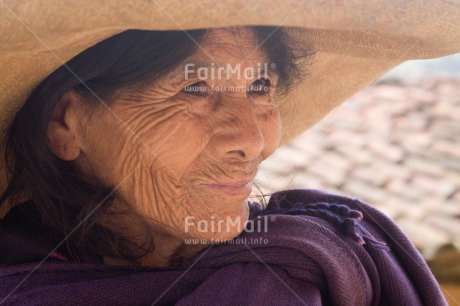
[255, 54, 460, 305]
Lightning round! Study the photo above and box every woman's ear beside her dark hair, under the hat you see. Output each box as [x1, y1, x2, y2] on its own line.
[47, 91, 81, 161]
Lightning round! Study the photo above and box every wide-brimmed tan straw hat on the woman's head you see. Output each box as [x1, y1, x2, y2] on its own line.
[0, 0, 460, 198]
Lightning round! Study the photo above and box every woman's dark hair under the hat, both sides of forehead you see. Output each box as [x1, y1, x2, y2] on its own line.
[0, 27, 312, 261]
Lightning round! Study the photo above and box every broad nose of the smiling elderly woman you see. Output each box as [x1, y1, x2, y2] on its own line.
[210, 98, 265, 161]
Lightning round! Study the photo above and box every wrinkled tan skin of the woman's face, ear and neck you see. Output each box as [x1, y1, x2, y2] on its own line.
[48, 29, 281, 266]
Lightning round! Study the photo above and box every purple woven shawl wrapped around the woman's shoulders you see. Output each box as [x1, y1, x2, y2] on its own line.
[0, 190, 447, 306]
